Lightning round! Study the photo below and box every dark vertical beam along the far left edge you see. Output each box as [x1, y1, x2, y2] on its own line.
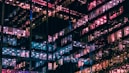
[0, 0, 5, 73]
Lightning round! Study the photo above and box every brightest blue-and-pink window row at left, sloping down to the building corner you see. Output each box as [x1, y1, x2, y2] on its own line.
[2, 47, 52, 60]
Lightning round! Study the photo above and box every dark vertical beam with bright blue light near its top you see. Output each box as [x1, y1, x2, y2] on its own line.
[29, 0, 33, 73]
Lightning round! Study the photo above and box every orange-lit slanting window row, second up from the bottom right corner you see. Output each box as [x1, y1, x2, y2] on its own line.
[75, 53, 129, 73]
